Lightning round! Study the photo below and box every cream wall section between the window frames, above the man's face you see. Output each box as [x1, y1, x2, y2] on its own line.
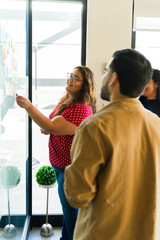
[86, 0, 133, 109]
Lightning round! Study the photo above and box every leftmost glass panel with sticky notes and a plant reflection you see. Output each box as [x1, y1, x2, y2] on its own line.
[0, 0, 28, 239]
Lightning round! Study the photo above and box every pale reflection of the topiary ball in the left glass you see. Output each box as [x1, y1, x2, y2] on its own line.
[0, 166, 21, 188]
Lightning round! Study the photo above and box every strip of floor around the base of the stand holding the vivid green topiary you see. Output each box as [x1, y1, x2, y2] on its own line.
[28, 228, 61, 240]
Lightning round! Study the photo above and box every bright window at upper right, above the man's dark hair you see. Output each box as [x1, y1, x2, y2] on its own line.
[133, 0, 160, 69]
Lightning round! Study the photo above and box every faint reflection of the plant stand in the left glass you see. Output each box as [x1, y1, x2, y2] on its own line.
[3, 188, 17, 238]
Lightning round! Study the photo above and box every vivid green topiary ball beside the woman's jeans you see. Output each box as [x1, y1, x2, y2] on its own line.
[36, 166, 57, 185]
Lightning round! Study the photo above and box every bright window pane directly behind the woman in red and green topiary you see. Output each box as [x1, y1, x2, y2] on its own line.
[32, 1, 83, 214]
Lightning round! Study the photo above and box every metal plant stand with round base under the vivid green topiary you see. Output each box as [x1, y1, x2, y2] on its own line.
[39, 183, 57, 237]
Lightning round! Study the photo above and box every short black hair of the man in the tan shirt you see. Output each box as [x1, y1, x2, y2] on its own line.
[110, 49, 152, 98]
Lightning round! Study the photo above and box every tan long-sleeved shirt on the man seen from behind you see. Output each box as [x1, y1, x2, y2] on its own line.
[64, 98, 160, 240]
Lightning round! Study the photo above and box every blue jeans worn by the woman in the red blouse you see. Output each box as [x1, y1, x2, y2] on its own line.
[52, 165, 78, 240]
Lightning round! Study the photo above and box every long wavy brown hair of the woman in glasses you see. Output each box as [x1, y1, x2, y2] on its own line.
[54, 66, 96, 116]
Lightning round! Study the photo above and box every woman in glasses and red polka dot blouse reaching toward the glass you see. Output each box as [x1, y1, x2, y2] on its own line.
[16, 66, 96, 240]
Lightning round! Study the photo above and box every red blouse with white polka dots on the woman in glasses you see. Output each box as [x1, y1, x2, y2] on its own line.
[49, 102, 93, 168]
